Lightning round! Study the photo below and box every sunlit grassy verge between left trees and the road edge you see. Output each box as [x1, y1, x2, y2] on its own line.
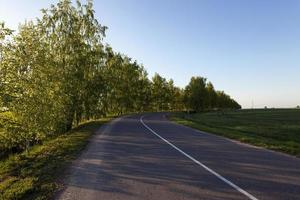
[0, 119, 109, 200]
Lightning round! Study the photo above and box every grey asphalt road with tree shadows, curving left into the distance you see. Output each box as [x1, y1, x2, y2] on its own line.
[58, 113, 300, 200]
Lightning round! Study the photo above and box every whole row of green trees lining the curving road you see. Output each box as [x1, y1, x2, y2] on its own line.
[0, 0, 240, 156]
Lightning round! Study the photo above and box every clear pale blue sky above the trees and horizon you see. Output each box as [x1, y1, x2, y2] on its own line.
[0, 0, 300, 108]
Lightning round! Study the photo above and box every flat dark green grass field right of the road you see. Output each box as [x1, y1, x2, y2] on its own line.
[171, 109, 300, 157]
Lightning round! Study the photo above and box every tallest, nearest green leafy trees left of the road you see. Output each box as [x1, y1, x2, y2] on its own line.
[0, 0, 105, 153]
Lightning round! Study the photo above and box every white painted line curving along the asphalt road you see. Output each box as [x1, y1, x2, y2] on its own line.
[140, 116, 258, 200]
